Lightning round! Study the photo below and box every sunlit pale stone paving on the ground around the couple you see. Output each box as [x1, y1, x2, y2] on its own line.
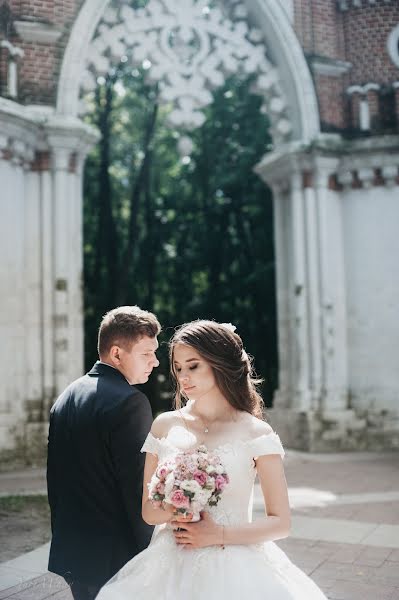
[0, 451, 399, 600]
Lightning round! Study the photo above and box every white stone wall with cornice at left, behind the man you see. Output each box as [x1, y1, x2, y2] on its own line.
[0, 99, 98, 462]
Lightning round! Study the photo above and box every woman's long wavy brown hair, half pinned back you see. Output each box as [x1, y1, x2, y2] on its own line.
[169, 319, 264, 419]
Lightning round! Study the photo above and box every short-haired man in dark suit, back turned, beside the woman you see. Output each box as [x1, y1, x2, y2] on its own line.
[47, 306, 161, 600]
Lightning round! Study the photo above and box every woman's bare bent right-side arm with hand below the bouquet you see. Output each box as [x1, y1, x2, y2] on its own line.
[175, 454, 291, 547]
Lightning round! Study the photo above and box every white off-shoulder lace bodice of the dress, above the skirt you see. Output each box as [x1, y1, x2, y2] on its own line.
[142, 426, 284, 525]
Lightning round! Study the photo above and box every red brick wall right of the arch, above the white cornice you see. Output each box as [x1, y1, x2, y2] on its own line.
[294, 0, 399, 130]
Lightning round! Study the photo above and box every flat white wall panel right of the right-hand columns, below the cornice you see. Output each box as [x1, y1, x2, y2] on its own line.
[343, 186, 399, 412]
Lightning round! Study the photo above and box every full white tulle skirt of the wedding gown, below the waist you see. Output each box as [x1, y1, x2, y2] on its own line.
[96, 527, 326, 600]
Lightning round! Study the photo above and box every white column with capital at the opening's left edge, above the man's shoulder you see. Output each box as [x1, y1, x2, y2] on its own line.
[47, 115, 98, 395]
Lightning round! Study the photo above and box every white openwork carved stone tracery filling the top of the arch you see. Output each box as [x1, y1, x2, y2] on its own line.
[81, 0, 292, 141]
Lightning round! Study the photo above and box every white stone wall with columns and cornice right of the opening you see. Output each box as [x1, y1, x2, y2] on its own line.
[256, 136, 399, 451]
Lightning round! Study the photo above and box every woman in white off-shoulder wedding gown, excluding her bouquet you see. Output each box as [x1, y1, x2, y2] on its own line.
[97, 320, 326, 600]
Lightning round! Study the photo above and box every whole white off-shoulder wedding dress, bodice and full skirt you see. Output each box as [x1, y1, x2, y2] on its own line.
[96, 426, 326, 600]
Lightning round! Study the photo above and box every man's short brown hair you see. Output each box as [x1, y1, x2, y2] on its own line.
[97, 306, 161, 356]
